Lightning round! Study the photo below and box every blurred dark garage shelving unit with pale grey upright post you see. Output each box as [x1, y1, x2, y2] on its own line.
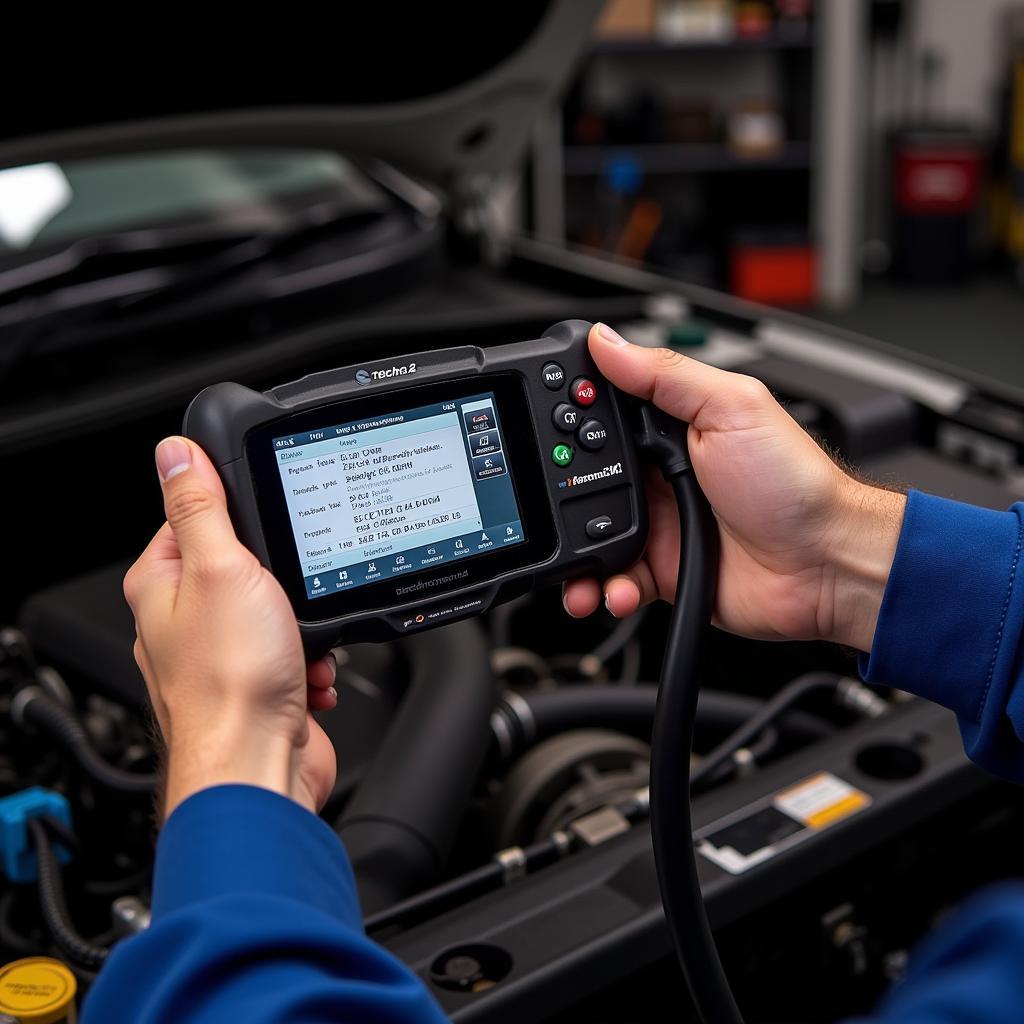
[531, 0, 864, 304]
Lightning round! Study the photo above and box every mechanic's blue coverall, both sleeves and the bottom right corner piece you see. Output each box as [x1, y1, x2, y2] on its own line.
[83, 492, 1024, 1024]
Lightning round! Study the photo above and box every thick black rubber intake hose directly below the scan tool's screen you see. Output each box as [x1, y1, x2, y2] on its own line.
[335, 620, 498, 914]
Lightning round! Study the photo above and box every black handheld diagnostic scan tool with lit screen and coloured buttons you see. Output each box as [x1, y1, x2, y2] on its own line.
[183, 321, 647, 656]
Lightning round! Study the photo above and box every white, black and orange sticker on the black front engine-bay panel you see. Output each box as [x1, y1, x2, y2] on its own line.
[693, 772, 871, 874]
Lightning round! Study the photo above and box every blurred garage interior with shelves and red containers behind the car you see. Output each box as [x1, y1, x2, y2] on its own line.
[531, 0, 1024, 382]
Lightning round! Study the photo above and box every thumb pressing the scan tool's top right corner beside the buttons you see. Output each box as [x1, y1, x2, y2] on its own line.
[589, 324, 746, 426]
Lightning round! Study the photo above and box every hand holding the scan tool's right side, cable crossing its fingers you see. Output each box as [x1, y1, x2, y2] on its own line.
[564, 324, 906, 650]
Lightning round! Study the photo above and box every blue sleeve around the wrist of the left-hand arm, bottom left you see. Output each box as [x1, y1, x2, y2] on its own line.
[83, 785, 445, 1024]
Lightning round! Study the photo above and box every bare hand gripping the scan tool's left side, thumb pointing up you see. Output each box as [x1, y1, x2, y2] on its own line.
[125, 437, 337, 814]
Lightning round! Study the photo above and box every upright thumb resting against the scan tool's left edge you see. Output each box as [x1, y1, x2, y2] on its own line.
[157, 437, 239, 569]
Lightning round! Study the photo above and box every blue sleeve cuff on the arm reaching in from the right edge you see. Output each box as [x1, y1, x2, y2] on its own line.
[861, 492, 1024, 781]
